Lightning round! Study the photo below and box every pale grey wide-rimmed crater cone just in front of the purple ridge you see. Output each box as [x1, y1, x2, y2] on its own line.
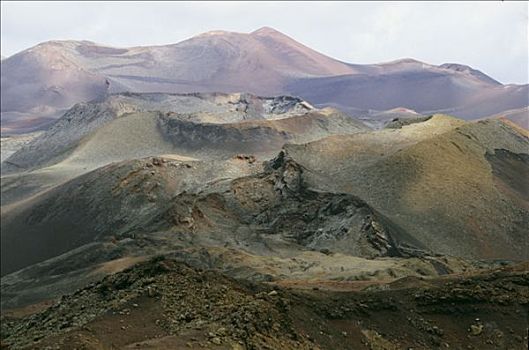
[2, 94, 369, 173]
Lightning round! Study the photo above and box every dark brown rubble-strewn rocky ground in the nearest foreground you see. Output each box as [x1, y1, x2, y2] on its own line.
[2, 257, 529, 349]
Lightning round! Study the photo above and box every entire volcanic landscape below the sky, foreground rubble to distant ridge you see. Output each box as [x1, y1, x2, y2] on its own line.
[0, 28, 529, 349]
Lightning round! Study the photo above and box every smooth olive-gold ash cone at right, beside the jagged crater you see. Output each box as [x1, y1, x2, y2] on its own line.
[285, 115, 529, 260]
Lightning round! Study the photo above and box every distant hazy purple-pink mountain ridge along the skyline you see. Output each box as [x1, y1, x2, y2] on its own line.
[1, 27, 529, 132]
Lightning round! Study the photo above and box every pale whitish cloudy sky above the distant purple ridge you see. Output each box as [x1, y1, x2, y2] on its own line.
[1, 1, 529, 84]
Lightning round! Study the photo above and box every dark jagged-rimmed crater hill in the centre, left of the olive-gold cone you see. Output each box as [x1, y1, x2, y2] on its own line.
[1, 153, 425, 274]
